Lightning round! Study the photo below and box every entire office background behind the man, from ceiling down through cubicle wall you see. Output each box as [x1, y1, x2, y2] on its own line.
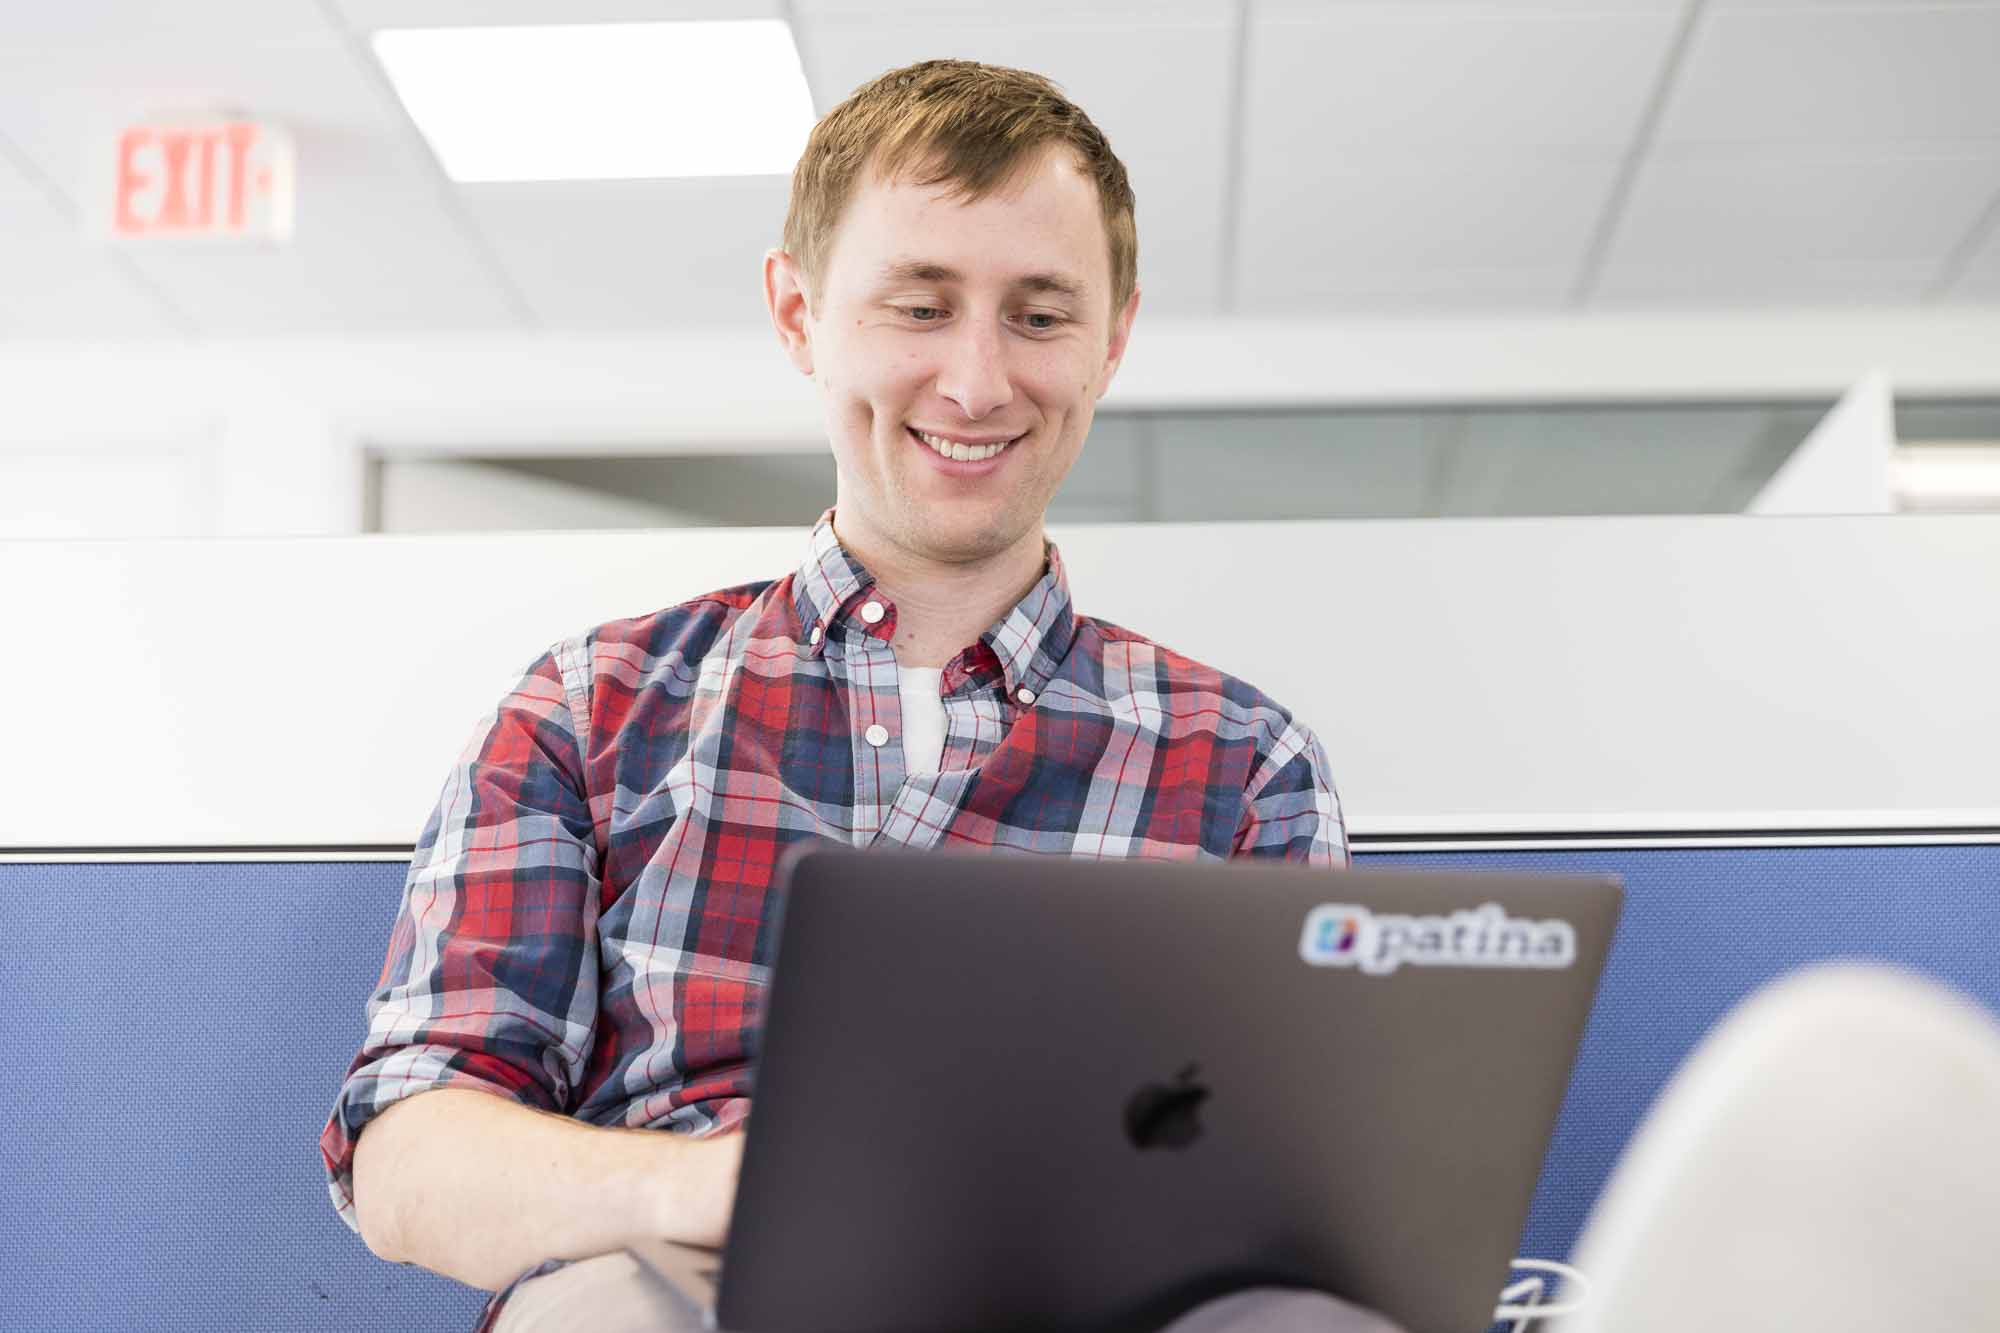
[0, 0, 2000, 1329]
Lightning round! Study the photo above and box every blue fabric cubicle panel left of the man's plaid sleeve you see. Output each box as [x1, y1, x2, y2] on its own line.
[0, 863, 484, 1333]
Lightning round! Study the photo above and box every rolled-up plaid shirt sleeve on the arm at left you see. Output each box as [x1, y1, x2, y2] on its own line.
[320, 650, 600, 1231]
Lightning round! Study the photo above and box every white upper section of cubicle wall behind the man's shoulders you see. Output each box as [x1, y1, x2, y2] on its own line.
[0, 514, 2000, 853]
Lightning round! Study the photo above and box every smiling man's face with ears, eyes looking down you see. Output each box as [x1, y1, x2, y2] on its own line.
[766, 150, 1138, 564]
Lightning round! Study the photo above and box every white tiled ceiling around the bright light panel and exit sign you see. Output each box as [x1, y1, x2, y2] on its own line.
[0, 0, 2000, 338]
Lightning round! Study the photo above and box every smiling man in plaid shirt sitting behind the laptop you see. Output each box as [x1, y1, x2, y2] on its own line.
[320, 62, 1384, 1329]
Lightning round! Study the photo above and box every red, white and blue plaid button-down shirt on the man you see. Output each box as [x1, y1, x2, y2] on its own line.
[320, 510, 1348, 1317]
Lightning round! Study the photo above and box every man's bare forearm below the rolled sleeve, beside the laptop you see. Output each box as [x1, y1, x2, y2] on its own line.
[354, 1089, 742, 1291]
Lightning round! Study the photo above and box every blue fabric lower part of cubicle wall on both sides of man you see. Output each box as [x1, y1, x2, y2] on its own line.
[0, 847, 2000, 1333]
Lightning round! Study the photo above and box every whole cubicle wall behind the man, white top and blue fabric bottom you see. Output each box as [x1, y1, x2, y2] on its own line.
[0, 518, 2000, 1331]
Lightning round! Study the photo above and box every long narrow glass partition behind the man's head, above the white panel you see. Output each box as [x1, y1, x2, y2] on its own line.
[368, 402, 1830, 532]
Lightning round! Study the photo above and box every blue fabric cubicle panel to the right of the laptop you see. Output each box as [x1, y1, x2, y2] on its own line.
[1356, 845, 2000, 1259]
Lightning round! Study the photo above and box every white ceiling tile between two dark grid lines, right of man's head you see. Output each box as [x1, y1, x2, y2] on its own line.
[1234, 6, 1676, 314]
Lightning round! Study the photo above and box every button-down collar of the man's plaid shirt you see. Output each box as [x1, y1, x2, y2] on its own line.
[792, 508, 1076, 697]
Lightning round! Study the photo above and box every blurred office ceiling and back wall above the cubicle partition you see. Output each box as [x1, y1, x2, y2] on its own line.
[0, 0, 2000, 538]
